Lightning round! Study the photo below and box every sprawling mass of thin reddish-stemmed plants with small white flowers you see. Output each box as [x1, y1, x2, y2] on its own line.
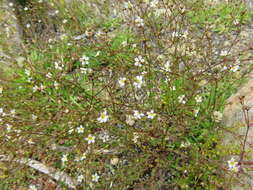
[0, 0, 251, 190]
